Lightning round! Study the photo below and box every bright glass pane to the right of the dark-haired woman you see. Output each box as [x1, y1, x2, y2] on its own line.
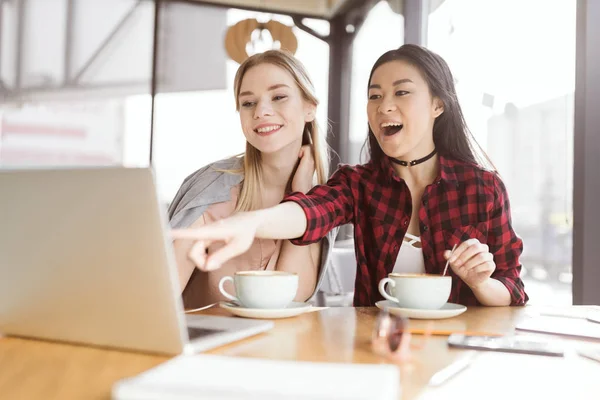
[428, 0, 576, 304]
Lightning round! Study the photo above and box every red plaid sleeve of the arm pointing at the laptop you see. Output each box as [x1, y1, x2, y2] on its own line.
[282, 167, 354, 245]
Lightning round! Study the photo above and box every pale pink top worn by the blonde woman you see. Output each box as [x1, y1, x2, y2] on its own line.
[183, 185, 281, 309]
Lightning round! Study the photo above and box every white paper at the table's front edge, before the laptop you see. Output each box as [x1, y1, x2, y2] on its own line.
[113, 354, 400, 400]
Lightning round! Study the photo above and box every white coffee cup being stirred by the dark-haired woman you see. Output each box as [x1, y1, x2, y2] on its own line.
[379, 273, 452, 310]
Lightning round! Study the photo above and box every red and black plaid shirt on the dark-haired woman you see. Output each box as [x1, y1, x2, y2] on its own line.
[284, 156, 528, 306]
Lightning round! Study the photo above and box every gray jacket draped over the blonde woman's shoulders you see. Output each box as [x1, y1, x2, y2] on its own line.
[168, 157, 338, 297]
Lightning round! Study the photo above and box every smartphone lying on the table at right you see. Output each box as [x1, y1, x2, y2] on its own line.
[448, 333, 564, 357]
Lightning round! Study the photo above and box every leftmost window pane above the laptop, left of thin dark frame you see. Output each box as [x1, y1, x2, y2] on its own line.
[0, 0, 154, 168]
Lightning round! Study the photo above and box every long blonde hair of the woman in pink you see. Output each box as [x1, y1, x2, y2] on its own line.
[230, 50, 329, 212]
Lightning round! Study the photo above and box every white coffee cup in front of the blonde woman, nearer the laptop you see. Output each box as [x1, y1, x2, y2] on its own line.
[219, 271, 298, 309]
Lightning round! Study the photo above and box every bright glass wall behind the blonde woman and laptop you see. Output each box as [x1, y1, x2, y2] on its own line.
[0, 0, 329, 208]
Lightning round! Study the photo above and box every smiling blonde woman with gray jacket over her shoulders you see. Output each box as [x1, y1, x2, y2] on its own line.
[169, 50, 334, 308]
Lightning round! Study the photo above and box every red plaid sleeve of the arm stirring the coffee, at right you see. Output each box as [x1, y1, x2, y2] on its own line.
[488, 175, 529, 306]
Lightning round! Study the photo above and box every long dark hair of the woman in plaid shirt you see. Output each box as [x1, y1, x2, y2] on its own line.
[365, 44, 495, 170]
